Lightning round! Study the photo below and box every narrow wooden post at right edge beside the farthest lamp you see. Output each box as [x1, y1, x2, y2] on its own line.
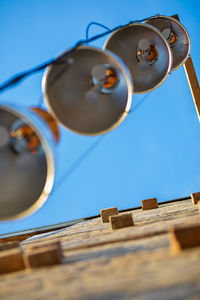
[172, 15, 200, 121]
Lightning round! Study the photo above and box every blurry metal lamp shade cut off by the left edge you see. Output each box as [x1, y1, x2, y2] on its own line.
[0, 103, 55, 220]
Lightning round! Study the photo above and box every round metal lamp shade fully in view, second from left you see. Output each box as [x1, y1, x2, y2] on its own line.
[42, 46, 133, 135]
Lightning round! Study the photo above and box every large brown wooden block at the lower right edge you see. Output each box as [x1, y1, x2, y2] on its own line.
[170, 224, 200, 254]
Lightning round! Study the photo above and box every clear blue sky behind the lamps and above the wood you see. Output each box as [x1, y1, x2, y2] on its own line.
[0, 0, 200, 234]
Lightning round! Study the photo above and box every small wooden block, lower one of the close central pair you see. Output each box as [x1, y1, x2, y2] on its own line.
[109, 213, 134, 230]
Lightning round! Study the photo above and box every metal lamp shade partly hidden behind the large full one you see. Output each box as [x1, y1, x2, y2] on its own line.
[104, 23, 172, 93]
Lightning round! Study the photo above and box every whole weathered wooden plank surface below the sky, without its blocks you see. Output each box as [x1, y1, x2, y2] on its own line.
[0, 200, 200, 300]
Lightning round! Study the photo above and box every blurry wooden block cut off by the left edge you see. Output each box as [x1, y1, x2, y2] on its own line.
[0, 249, 25, 274]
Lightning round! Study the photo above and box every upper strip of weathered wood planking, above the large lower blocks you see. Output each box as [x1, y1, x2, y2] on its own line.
[22, 200, 200, 249]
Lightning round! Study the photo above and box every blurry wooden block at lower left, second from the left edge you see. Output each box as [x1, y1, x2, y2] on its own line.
[25, 246, 62, 268]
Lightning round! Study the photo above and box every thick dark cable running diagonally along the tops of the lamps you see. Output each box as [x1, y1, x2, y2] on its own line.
[0, 15, 158, 92]
